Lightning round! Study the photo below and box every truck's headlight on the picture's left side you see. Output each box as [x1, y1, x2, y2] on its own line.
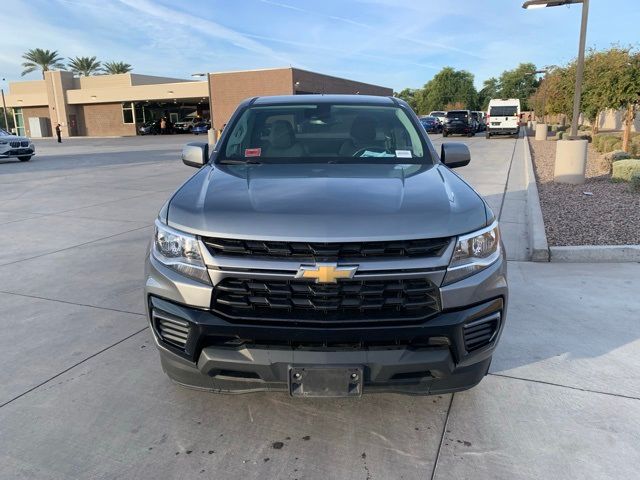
[152, 220, 211, 285]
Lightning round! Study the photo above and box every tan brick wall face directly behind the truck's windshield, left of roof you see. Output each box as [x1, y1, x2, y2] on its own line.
[210, 68, 293, 129]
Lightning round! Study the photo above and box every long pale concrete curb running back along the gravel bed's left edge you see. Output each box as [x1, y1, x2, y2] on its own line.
[523, 129, 551, 262]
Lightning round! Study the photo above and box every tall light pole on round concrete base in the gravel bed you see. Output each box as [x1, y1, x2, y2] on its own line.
[522, 0, 589, 184]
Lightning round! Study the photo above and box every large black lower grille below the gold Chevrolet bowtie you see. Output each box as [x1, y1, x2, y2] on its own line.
[212, 278, 441, 328]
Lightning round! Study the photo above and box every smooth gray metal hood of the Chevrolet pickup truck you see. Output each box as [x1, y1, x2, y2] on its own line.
[167, 164, 487, 242]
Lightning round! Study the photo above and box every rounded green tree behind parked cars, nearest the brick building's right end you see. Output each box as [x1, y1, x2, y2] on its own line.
[418, 67, 478, 113]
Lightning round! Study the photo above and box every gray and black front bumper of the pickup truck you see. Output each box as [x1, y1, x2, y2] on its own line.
[145, 251, 508, 394]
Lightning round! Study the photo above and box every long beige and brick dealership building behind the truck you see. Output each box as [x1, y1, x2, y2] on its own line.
[6, 68, 393, 137]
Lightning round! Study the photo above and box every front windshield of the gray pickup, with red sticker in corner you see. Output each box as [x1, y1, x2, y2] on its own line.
[219, 103, 430, 163]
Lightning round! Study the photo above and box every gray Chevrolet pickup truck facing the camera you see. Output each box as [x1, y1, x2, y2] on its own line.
[145, 95, 508, 397]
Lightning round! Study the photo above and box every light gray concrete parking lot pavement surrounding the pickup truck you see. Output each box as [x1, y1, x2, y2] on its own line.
[0, 136, 640, 480]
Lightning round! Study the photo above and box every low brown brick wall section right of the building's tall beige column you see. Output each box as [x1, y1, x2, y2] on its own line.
[77, 103, 136, 137]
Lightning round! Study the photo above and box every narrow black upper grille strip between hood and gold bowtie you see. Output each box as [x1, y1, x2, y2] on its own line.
[203, 238, 450, 260]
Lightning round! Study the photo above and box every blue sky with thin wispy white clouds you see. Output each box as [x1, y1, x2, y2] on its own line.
[0, 0, 640, 91]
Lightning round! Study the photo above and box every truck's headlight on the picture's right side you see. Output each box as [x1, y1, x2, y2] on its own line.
[444, 222, 501, 285]
